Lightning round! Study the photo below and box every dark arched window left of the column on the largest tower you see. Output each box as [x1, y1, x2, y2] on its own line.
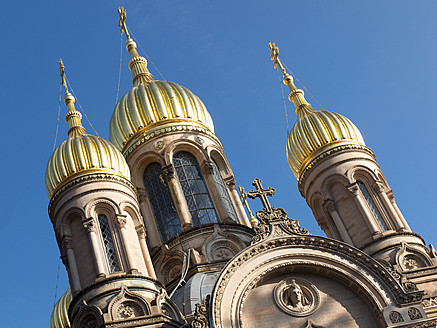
[143, 163, 182, 242]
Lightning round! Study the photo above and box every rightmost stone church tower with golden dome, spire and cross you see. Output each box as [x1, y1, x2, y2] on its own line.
[270, 44, 437, 310]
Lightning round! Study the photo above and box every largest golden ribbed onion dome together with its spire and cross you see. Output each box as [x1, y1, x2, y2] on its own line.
[109, 16, 214, 153]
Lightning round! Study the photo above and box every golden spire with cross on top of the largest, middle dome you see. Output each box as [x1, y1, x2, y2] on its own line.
[118, 7, 153, 85]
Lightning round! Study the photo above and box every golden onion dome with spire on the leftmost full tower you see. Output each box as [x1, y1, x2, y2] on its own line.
[45, 61, 130, 198]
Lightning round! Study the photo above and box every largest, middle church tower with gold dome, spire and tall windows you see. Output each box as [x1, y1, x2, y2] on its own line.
[109, 8, 253, 315]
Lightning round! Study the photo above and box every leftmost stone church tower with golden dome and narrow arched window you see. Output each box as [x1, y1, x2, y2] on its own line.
[45, 61, 183, 328]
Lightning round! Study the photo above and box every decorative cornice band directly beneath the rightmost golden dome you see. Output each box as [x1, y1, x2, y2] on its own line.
[298, 144, 376, 197]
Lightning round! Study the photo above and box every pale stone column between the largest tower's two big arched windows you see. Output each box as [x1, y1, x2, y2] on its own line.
[162, 164, 193, 230]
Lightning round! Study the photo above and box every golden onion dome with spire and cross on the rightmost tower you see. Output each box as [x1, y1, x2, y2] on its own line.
[269, 43, 365, 179]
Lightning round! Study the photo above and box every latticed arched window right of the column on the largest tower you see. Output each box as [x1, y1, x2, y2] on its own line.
[173, 151, 218, 226]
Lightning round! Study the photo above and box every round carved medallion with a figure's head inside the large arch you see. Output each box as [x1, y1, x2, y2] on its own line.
[273, 278, 320, 317]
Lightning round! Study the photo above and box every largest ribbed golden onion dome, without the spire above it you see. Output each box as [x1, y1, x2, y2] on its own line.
[109, 81, 214, 150]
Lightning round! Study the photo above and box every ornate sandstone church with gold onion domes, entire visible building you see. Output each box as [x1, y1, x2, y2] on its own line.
[46, 9, 437, 328]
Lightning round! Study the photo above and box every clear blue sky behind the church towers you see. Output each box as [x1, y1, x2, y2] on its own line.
[0, 0, 437, 327]
